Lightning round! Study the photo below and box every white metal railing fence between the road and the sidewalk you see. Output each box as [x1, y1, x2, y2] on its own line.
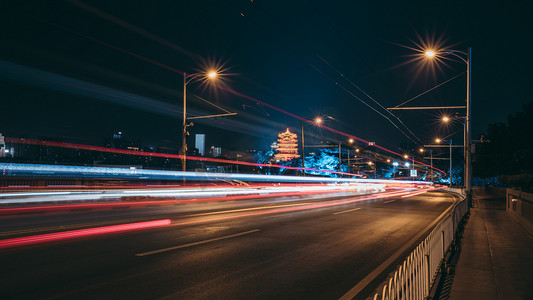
[373, 191, 468, 300]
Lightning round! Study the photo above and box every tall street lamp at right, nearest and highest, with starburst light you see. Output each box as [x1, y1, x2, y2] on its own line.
[425, 47, 472, 207]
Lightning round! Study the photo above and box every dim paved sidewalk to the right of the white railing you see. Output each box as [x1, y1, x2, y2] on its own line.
[448, 194, 533, 300]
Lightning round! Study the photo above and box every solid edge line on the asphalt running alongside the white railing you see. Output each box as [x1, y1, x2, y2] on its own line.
[339, 195, 455, 300]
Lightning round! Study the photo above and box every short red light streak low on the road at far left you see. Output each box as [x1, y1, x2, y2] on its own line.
[0, 219, 170, 249]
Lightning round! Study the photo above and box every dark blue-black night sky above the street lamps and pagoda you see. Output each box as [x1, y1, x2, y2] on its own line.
[0, 0, 533, 151]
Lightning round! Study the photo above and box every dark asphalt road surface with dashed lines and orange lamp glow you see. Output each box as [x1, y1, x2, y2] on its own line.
[0, 192, 454, 299]
